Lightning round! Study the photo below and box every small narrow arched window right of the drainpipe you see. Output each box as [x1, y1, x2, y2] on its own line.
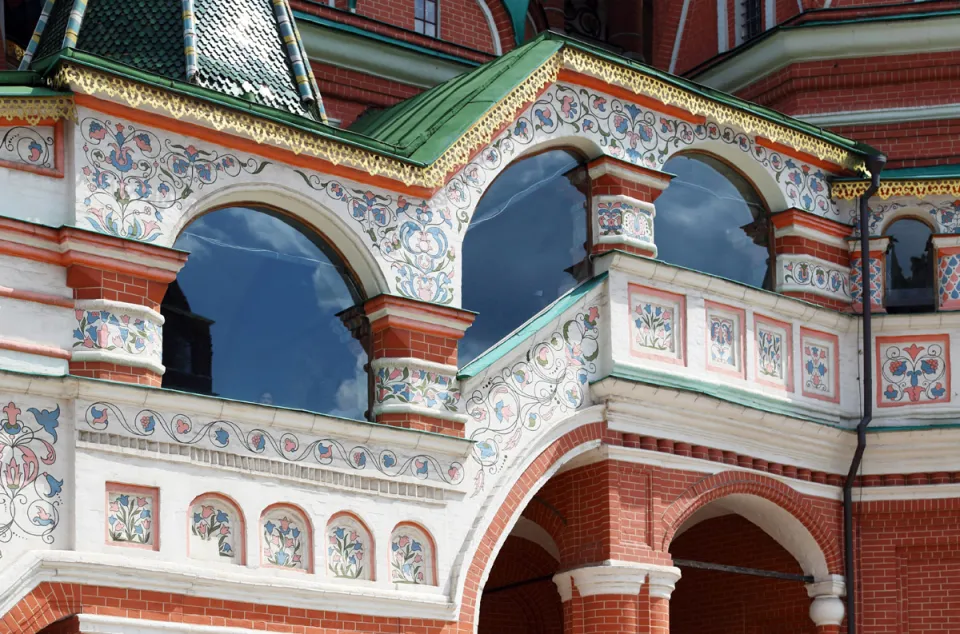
[884, 218, 936, 313]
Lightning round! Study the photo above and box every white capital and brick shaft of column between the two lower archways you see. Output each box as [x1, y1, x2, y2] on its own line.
[553, 561, 680, 634]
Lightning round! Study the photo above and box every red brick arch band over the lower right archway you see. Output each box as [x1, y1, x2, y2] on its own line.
[660, 471, 843, 574]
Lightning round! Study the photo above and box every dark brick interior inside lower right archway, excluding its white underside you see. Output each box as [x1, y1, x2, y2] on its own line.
[670, 504, 817, 634]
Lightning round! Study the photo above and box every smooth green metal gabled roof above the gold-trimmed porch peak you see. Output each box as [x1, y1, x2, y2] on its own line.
[351, 32, 878, 164]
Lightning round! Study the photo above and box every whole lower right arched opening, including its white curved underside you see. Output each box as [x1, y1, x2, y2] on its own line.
[670, 495, 826, 634]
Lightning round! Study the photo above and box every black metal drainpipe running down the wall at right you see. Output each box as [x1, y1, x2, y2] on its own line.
[843, 154, 887, 634]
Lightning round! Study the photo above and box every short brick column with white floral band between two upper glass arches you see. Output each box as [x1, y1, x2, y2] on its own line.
[587, 156, 672, 258]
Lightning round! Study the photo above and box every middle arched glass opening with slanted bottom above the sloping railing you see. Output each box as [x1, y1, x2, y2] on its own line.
[459, 150, 589, 363]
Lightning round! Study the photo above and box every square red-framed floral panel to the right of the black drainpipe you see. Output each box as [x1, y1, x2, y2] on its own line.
[880, 341, 950, 405]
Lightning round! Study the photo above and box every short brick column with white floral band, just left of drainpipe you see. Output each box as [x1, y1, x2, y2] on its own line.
[773, 209, 852, 311]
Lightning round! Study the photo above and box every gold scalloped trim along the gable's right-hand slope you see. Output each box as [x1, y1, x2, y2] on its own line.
[563, 48, 866, 173]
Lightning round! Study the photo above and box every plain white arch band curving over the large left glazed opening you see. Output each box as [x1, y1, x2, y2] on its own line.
[170, 182, 391, 298]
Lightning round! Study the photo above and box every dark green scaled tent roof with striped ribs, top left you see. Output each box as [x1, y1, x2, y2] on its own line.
[28, 0, 322, 119]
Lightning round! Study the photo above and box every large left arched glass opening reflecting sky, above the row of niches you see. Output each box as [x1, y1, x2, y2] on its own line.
[161, 207, 369, 418]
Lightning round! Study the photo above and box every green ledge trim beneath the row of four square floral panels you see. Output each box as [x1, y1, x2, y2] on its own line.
[590, 363, 855, 431]
